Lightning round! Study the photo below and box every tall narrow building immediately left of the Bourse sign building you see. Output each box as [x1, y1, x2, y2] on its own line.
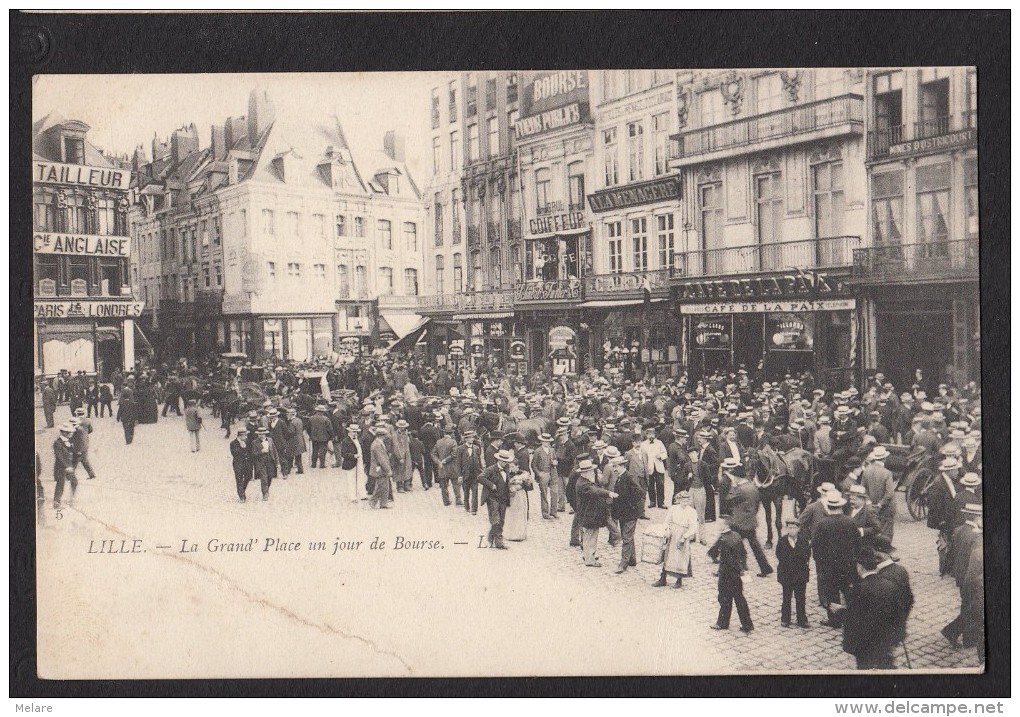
[421, 72, 522, 368]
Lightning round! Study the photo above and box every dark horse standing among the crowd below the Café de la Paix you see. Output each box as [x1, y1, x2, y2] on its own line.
[750, 444, 816, 548]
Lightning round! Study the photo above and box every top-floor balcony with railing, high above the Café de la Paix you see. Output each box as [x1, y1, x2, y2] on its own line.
[670, 95, 864, 166]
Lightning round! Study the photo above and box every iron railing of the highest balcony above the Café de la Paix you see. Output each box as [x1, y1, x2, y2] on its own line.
[670, 95, 864, 159]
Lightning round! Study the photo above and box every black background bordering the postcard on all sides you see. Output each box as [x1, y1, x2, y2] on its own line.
[9, 10, 1010, 698]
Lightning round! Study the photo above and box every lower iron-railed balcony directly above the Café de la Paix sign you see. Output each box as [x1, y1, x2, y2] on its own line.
[673, 237, 861, 277]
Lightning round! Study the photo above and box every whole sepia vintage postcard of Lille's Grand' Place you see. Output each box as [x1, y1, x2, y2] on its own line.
[32, 66, 985, 680]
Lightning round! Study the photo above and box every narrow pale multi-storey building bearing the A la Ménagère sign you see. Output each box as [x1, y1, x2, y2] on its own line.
[581, 69, 681, 375]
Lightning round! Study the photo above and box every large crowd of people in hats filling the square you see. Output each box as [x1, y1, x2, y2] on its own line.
[38, 356, 983, 669]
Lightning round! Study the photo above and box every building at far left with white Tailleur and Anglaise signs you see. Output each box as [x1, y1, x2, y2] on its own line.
[33, 114, 144, 378]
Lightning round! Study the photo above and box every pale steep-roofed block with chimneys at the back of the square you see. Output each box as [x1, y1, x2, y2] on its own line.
[134, 91, 422, 361]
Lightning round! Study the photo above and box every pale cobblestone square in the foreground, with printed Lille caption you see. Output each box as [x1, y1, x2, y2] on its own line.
[36, 406, 978, 678]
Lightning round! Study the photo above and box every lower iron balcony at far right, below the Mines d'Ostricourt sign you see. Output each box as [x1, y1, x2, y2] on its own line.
[852, 237, 978, 284]
